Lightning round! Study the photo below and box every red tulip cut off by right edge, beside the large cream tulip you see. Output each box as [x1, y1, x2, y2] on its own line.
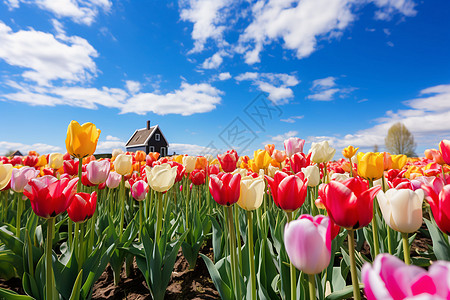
[422, 182, 450, 235]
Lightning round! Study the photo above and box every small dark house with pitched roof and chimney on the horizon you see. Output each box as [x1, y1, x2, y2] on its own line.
[125, 121, 169, 156]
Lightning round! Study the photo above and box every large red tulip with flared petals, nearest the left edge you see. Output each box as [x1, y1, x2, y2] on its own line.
[23, 176, 78, 219]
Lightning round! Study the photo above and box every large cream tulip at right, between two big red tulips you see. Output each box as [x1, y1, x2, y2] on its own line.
[377, 188, 424, 233]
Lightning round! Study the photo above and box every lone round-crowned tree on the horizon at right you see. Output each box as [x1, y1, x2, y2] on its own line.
[384, 122, 416, 156]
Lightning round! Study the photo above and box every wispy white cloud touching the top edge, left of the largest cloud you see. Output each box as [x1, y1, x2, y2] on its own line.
[179, 0, 233, 53]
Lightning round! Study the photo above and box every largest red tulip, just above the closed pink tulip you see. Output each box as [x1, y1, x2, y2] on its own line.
[319, 177, 381, 229]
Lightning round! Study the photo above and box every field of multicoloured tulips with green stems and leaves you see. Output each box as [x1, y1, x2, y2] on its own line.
[0, 121, 450, 300]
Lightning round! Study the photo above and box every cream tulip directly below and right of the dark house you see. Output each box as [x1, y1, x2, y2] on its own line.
[145, 164, 177, 193]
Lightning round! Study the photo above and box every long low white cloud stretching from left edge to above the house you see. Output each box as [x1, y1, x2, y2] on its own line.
[0, 81, 223, 116]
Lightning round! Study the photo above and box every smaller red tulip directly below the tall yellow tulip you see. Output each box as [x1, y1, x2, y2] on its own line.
[67, 192, 97, 223]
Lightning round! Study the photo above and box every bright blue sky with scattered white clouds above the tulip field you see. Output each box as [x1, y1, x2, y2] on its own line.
[0, 0, 450, 158]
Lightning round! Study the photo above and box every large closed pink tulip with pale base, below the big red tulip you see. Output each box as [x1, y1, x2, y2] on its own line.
[284, 215, 331, 274]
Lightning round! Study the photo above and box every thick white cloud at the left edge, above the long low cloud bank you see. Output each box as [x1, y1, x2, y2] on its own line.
[0, 21, 98, 85]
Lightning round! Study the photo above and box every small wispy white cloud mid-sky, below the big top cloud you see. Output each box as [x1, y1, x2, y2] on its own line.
[235, 72, 300, 105]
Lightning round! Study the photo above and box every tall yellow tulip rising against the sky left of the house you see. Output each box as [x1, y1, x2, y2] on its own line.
[66, 121, 101, 158]
